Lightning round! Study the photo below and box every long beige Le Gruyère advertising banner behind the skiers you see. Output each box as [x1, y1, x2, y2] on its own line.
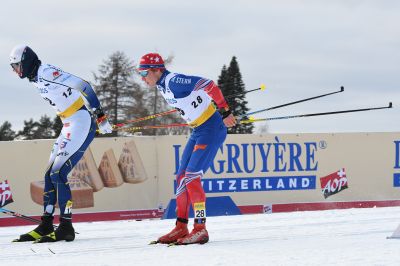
[0, 133, 400, 225]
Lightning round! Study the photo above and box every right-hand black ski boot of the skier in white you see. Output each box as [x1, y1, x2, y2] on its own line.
[35, 215, 75, 243]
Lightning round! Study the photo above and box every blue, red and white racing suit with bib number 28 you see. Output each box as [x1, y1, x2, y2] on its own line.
[157, 70, 228, 223]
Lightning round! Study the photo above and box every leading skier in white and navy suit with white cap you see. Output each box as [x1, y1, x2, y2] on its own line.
[10, 45, 112, 243]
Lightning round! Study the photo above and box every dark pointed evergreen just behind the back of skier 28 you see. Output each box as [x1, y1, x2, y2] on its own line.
[218, 56, 254, 134]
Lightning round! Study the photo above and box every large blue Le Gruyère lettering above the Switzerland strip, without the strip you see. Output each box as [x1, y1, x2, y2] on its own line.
[173, 137, 318, 175]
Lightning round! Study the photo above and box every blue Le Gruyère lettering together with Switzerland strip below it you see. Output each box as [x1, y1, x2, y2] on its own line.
[173, 137, 320, 193]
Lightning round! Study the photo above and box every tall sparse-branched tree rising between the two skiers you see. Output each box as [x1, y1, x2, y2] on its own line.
[94, 51, 149, 135]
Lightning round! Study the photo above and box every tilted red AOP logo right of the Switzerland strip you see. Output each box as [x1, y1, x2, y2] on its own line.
[320, 168, 348, 198]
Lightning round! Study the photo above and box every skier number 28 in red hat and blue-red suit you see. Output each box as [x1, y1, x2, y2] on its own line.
[138, 53, 236, 245]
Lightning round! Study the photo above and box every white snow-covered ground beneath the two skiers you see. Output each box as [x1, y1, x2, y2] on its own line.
[0, 207, 400, 266]
